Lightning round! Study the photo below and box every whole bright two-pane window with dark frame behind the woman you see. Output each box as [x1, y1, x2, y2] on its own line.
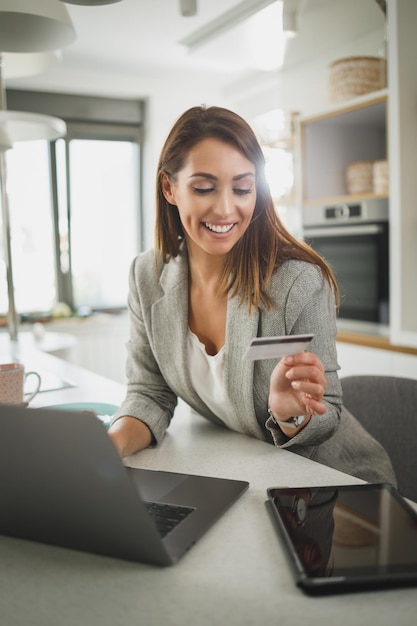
[0, 91, 141, 316]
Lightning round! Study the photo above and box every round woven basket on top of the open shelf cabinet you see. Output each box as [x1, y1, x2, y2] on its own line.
[329, 57, 387, 102]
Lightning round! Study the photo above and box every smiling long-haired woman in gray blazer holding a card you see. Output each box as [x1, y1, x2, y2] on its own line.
[109, 107, 395, 483]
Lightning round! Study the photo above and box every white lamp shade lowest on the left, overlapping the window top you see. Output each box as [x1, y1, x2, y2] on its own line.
[0, 110, 67, 143]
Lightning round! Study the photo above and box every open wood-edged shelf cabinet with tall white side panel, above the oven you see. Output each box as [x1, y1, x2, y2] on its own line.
[298, 0, 417, 347]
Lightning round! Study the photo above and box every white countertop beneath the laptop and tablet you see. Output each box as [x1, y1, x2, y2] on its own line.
[0, 348, 417, 626]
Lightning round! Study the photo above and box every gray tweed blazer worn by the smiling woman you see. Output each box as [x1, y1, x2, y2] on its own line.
[114, 250, 395, 484]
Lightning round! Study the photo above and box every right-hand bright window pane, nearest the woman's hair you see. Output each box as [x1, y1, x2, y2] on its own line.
[56, 131, 140, 310]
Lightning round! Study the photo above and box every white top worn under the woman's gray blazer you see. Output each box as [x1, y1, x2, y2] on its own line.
[188, 330, 243, 432]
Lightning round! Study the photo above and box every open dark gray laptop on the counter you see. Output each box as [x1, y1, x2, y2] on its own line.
[0, 405, 249, 566]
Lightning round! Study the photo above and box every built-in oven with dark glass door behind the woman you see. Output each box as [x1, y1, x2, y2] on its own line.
[303, 198, 389, 324]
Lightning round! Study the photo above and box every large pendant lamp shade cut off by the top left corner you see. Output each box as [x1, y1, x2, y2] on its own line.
[0, 0, 76, 52]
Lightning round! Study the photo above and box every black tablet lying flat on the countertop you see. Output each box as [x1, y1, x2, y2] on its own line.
[266, 483, 417, 595]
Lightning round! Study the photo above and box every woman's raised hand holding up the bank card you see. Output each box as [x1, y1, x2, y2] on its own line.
[269, 352, 327, 421]
